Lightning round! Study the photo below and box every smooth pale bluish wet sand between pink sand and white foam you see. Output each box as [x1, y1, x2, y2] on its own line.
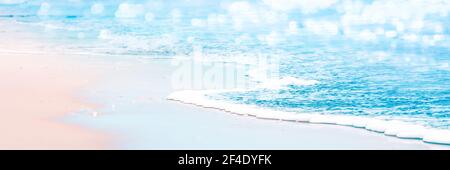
[64, 58, 449, 150]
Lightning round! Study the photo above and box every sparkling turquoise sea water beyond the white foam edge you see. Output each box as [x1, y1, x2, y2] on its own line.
[0, 0, 450, 129]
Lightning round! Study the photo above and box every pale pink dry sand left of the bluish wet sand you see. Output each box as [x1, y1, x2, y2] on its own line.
[0, 25, 108, 149]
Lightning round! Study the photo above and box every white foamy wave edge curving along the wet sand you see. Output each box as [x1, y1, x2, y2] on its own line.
[167, 90, 450, 145]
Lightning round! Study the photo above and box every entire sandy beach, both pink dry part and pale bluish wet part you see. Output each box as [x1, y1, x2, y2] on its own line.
[0, 20, 449, 149]
